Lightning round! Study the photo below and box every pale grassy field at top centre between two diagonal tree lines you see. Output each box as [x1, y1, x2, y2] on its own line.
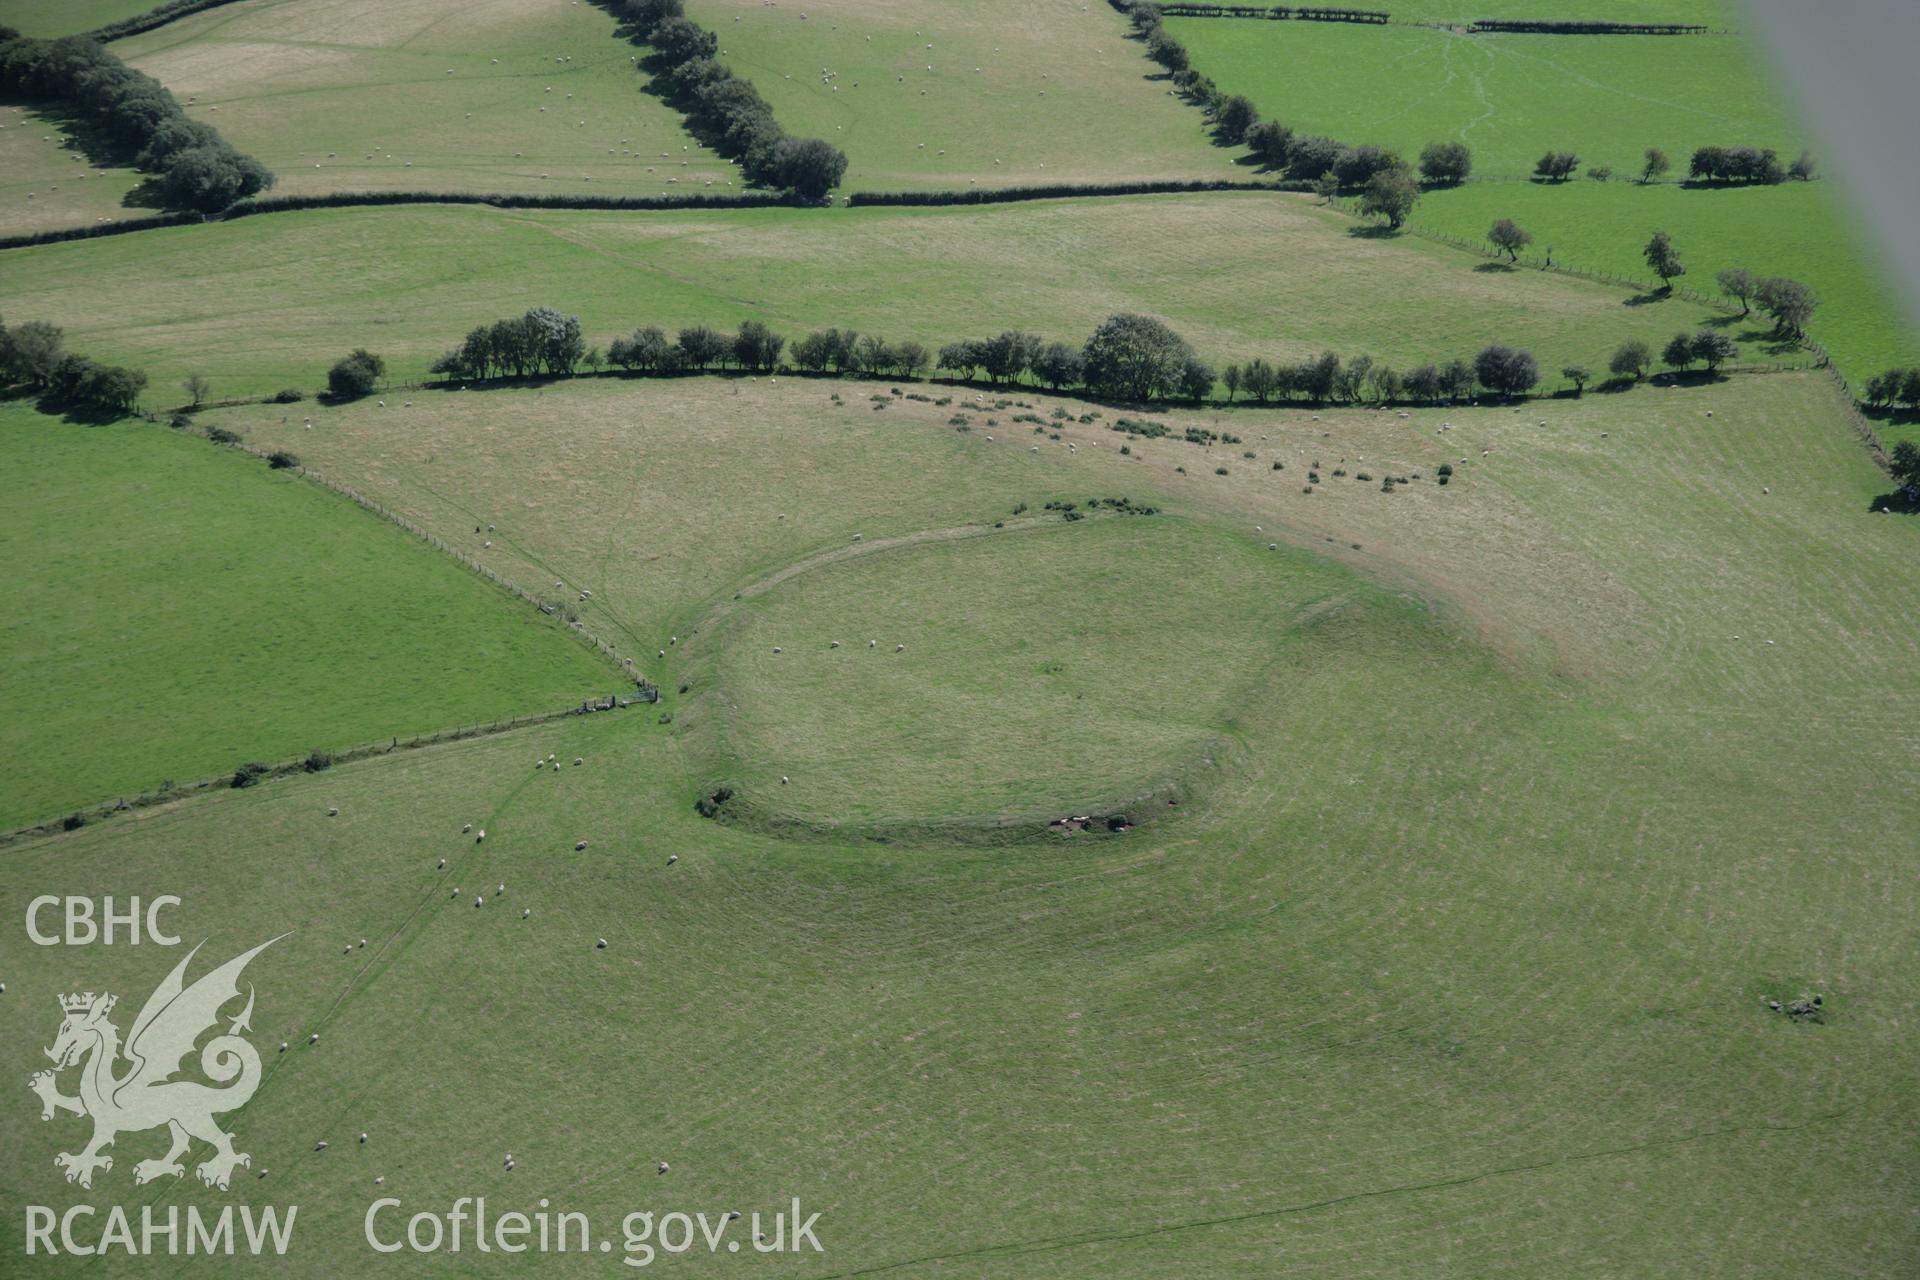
[687, 0, 1238, 192]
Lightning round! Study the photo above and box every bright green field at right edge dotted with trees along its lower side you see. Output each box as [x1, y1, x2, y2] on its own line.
[1411, 182, 1920, 386]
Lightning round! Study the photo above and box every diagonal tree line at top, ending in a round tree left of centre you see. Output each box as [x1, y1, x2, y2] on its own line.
[624, 0, 847, 200]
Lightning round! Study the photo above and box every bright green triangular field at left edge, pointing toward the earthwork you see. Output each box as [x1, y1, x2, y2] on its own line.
[0, 407, 618, 829]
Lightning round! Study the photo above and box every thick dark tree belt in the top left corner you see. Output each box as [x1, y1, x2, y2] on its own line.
[0, 27, 273, 213]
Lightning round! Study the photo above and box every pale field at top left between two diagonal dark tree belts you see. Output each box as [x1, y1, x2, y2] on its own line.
[113, 0, 739, 196]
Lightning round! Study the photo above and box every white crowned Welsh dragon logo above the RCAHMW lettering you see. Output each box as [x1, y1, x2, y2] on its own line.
[29, 935, 286, 1192]
